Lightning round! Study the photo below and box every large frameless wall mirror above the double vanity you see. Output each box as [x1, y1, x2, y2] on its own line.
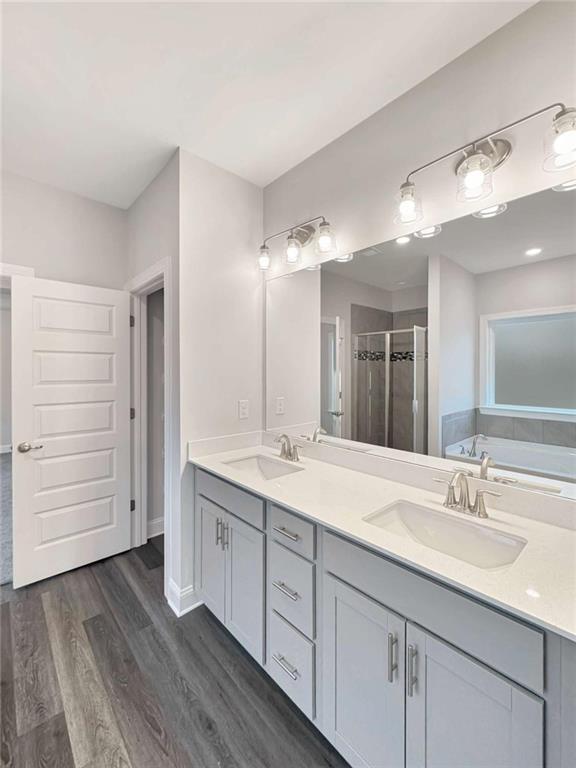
[266, 185, 576, 493]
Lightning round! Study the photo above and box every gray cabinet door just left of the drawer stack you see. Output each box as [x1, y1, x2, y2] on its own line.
[224, 515, 265, 663]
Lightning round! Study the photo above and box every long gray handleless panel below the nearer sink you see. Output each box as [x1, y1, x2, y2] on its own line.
[323, 532, 544, 695]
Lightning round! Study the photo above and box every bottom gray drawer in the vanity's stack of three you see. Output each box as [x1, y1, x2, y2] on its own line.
[268, 611, 315, 720]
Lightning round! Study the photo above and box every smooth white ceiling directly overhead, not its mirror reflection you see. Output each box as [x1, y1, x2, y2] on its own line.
[2, 2, 533, 208]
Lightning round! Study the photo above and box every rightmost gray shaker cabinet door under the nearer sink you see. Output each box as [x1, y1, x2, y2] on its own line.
[406, 624, 544, 768]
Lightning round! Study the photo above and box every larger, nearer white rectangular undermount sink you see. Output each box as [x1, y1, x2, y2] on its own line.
[364, 501, 526, 568]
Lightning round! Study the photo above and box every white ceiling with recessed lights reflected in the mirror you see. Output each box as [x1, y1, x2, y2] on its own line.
[322, 189, 576, 291]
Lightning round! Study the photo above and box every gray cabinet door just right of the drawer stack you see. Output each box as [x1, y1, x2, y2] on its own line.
[324, 576, 405, 768]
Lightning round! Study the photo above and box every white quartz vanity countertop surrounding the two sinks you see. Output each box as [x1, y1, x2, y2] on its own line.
[190, 446, 576, 641]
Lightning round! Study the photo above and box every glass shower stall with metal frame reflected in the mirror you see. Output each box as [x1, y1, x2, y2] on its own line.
[352, 325, 428, 453]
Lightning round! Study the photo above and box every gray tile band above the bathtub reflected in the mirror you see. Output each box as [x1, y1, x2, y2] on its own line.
[442, 408, 576, 452]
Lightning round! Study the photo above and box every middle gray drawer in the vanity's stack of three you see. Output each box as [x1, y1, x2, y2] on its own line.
[269, 541, 316, 639]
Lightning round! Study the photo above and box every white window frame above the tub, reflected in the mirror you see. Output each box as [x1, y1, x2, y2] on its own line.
[478, 304, 576, 421]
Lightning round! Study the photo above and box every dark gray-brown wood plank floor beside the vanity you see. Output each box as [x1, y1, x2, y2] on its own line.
[0, 539, 347, 768]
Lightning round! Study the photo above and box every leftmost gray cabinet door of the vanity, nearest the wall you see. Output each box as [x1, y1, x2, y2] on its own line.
[196, 496, 226, 621]
